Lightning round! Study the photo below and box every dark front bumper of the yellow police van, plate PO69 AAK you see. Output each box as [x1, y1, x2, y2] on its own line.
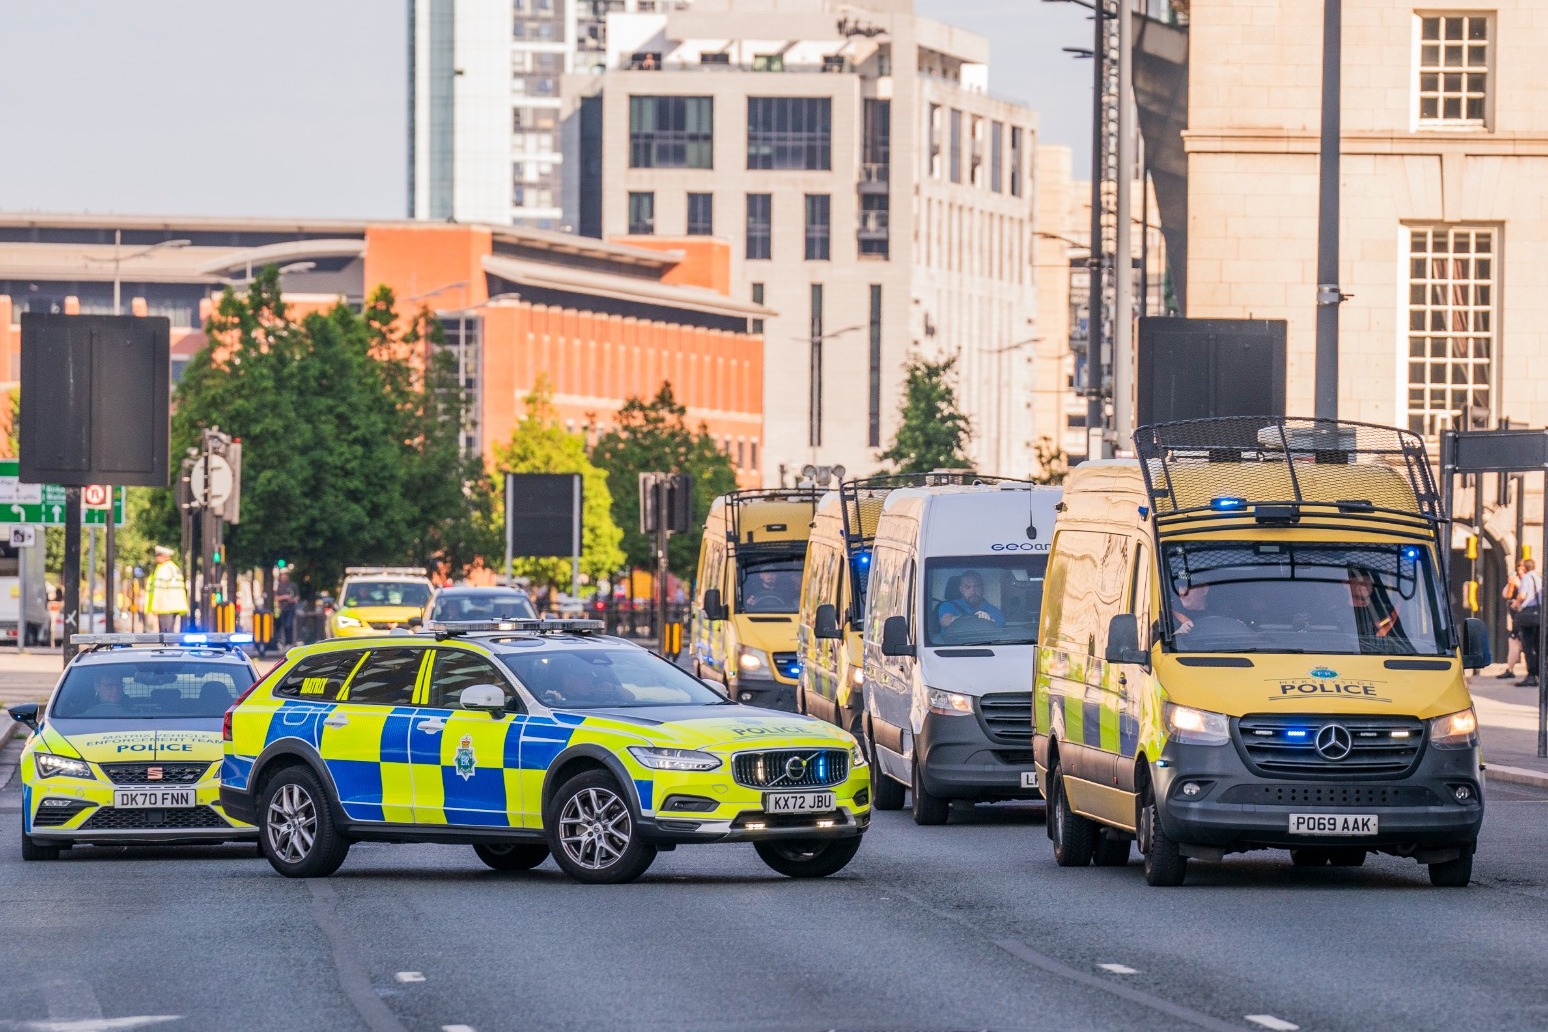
[1150, 743, 1483, 863]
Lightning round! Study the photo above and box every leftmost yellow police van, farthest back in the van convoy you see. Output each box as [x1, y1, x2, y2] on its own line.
[692, 487, 819, 710]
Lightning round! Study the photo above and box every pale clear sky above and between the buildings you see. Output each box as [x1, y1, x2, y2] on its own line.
[0, 0, 1091, 218]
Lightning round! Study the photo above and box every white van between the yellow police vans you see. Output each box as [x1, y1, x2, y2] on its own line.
[862, 481, 1062, 825]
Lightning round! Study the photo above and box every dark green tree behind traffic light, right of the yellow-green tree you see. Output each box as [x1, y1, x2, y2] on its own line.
[591, 382, 737, 577]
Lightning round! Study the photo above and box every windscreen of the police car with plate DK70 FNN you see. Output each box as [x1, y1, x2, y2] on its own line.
[50, 659, 252, 721]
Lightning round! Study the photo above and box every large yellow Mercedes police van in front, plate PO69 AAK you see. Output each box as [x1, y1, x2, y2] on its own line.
[1034, 418, 1489, 885]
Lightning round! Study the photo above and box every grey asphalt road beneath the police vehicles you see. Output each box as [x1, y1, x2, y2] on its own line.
[0, 758, 1548, 1032]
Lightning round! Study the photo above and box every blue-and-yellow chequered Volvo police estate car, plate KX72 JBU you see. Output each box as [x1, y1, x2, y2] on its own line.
[220, 620, 870, 883]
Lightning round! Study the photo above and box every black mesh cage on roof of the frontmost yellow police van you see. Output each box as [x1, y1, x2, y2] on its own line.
[1135, 416, 1446, 535]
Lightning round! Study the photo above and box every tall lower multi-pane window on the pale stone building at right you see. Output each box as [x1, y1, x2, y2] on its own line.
[1407, 226, 1498, 436]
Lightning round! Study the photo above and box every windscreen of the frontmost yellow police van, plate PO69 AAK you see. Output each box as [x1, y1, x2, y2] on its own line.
[1161, 542, 1450, 656]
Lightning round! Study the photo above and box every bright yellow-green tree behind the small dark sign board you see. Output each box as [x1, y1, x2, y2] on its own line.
[494, 376, 624, 586]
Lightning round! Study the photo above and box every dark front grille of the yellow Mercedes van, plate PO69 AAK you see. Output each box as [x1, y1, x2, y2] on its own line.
[1237, 713, 1426, 778]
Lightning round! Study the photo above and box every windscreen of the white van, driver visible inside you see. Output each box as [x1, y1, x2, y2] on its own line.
[924, 552, 1048, 647]
